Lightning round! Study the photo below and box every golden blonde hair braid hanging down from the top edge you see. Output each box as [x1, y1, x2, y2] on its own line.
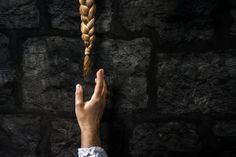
[79, 0, 96, 79]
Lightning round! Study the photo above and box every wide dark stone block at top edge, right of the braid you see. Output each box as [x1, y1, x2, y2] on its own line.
[119, 0, 217, 47]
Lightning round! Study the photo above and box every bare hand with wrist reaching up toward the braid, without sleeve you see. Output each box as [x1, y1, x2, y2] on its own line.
[75, 69, 107, 147]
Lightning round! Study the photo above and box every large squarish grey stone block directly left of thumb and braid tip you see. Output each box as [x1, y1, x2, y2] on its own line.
[22, 37, 83, 111]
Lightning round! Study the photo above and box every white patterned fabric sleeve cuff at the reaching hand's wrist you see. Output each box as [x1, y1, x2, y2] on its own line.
[78, 146, 108, 157]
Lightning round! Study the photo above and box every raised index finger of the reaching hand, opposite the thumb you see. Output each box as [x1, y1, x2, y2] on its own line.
[92, 69, 104, 99]
